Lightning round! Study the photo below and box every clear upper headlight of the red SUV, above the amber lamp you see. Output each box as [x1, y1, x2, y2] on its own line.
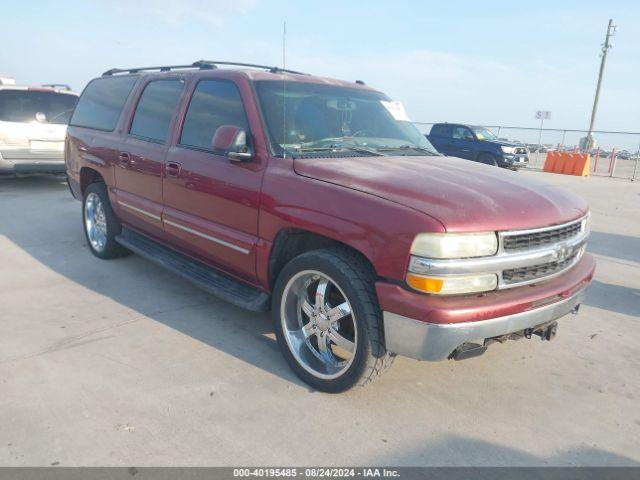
[411, 232, 498, 258]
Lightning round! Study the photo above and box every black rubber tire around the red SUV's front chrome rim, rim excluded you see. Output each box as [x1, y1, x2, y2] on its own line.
[272, 247, 395, 393]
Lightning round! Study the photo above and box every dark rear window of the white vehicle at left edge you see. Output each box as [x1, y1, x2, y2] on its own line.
[0, 90, 78, 124]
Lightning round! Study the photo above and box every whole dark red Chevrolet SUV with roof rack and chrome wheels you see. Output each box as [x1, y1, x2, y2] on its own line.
[65, 61, 595, 392]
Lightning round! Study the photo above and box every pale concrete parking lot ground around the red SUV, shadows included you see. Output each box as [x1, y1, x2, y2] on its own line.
[0, 171, 640, 466]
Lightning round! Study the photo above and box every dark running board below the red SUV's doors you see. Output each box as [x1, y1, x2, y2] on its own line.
[116, 228, 271, 312]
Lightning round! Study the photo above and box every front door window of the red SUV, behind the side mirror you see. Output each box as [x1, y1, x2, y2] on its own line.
[180, 80, 248, 150]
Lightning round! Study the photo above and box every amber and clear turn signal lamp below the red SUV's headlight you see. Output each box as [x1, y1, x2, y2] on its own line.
[407, 273, 498, 295]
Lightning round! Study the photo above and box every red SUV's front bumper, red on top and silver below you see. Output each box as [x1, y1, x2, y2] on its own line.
[376, 254, 595, 361]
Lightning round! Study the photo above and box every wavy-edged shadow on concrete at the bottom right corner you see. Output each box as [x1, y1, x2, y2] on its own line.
[365, 434, 640, 466]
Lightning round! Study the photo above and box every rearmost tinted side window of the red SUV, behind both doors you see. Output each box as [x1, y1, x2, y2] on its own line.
[69, 77, 137, 132]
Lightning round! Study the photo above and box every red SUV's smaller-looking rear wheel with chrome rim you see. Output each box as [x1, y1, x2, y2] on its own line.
[82, 182, 130, 259]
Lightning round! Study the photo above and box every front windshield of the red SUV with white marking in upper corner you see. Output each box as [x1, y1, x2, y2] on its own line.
[256, 81, 438, 156]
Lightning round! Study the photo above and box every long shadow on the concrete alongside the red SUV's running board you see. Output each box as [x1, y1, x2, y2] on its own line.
[0, 176, 309, 389]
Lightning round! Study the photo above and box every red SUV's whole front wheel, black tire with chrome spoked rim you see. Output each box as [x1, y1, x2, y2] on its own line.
[272, 248, 394, 393]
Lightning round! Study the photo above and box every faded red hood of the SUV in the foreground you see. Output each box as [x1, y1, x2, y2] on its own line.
[294, 156, 588, 232]
